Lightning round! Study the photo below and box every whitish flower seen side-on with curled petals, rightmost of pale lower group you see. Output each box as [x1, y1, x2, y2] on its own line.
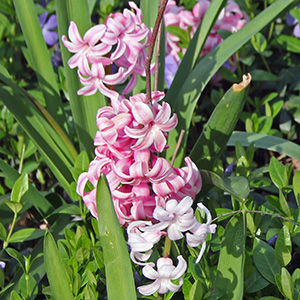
[186, 203, 217, 263]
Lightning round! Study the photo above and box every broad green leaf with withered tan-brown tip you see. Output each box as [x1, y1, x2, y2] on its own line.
[190, 75, 251, 170]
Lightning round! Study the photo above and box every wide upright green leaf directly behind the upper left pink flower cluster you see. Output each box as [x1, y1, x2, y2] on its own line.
[56, 0, 106, 157]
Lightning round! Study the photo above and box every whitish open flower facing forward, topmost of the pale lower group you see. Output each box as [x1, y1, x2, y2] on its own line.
[143, 197, 196, 241]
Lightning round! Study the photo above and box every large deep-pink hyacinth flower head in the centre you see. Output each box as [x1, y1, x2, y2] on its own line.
[77, 91, 201, 226]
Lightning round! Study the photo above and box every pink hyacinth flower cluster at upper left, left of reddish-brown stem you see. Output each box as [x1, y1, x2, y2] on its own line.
[62, 1, 153, 98]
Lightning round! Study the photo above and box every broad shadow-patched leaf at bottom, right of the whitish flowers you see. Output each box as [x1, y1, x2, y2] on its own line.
[209, 214, 246, 300]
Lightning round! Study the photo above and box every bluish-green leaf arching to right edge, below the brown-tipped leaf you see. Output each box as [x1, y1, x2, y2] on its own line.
[227, 131, 300, 161]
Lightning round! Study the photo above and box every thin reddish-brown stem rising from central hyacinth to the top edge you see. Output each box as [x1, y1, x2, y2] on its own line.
[145, 0, 168, 102]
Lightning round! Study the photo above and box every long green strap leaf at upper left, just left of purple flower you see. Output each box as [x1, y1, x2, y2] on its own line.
[14, 0, 67, 135]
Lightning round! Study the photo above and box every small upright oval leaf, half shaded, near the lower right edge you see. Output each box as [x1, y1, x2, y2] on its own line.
[275, 225, 292, 267]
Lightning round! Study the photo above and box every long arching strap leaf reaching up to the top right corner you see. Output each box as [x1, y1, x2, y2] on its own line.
[166, 0, 297, 167]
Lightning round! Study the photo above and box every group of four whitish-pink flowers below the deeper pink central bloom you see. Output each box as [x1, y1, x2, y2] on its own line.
[127, 196, 216, 296]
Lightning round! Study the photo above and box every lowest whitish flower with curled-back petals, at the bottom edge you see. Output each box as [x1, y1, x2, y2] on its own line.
[138, 255, 187, 296]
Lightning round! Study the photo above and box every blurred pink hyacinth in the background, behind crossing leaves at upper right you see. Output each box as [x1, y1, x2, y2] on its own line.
[164, 0, 248, 87]
